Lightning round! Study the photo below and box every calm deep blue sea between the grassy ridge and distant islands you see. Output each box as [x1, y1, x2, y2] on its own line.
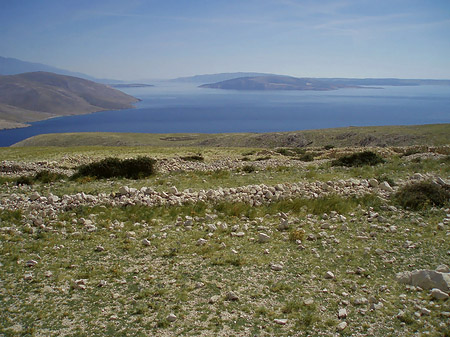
[0, 82, 450, 146]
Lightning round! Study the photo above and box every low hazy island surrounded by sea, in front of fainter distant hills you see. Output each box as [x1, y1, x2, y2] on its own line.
[200, 75, 376, 91]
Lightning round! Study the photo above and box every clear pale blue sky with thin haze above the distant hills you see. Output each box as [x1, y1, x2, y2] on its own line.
[0, 0, 450, 80]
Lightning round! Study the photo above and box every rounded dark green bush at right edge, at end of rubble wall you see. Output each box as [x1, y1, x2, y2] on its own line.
[394, 181, 450, 210]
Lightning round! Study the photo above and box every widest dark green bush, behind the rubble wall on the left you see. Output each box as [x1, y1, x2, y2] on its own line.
[74, 157, 156, 179]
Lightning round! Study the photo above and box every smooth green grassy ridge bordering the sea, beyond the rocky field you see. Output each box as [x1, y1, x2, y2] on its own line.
[9, 124, 450, 147]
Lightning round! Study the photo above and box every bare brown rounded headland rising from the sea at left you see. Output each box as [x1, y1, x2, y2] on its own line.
[0, 71, 139, 129]
